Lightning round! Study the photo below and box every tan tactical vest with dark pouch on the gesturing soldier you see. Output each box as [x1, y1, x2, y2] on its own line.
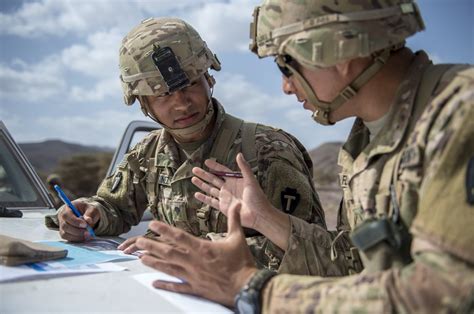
[344, 65, 458, 272]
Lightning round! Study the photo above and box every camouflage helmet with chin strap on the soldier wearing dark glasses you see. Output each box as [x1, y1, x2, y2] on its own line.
[250, 0, 424, 125]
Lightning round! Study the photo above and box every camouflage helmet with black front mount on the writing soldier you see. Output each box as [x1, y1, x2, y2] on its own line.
[119, 18, 221, 105]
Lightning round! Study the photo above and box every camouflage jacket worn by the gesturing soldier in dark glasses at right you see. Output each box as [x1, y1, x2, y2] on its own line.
[262, 52, 474, 313]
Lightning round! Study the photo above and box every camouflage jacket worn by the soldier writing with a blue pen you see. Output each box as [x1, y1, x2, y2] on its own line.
[47, 99, 325, 269]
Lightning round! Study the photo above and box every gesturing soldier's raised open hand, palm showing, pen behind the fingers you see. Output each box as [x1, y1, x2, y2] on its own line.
[191, 153, 273, 230]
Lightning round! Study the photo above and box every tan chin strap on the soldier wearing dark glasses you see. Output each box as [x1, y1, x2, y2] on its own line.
[285, 49, 391, 125]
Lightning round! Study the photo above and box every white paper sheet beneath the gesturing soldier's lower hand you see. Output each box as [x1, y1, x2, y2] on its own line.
[133, 271, 234, 313]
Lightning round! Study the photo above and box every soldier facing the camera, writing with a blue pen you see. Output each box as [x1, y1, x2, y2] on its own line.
[47, 18, 326, 269]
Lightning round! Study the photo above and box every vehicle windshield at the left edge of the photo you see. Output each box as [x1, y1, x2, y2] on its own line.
[0, 132, 48, 208]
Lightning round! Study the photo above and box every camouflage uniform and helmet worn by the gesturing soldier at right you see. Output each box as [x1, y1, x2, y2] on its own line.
[251, 0, 474, 313]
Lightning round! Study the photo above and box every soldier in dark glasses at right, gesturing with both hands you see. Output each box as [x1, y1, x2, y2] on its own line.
[137, 0, 474, 313]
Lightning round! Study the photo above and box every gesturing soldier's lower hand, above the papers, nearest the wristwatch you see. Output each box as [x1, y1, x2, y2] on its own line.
[136, 203, 257, 306]
